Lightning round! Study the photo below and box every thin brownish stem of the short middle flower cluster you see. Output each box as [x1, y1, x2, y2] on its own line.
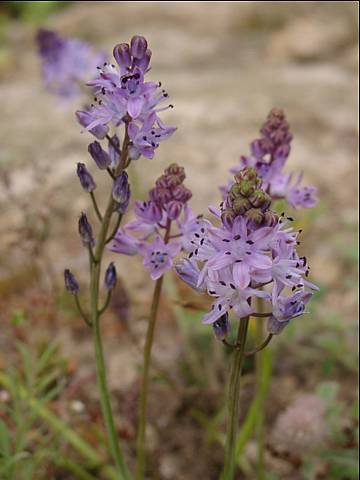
[135, 220, 171, 480]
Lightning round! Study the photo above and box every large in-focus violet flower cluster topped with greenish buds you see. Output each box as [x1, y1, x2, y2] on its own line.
[175, 167, 317, 339]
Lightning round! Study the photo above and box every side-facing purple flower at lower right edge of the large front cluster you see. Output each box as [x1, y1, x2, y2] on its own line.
[267, 284, 312, 335]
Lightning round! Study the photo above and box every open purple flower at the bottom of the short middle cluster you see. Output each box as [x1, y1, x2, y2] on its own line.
[139, 235, 181, 280]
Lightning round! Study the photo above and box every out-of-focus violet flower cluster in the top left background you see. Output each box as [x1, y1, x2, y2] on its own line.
[36, 29, 106, 98]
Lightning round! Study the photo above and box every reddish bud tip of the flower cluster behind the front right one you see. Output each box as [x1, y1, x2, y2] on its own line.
[251, 108, 293, 163]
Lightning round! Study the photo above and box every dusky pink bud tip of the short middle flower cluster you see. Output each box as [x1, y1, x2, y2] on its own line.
[149, 163, 192, 220]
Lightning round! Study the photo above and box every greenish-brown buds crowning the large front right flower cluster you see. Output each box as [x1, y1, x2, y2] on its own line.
[221, 167, 278, 228]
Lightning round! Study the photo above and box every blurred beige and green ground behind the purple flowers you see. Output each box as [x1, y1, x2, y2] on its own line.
[0, 2, 358, 480]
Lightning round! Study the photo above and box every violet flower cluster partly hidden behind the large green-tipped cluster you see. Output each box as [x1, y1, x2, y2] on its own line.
[221, 108, 318, 208]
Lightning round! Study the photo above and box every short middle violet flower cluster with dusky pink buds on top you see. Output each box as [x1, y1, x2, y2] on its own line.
[109, 163, 193, 280]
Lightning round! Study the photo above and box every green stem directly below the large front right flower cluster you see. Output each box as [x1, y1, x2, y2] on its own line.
[222, 317, 249, 480]
